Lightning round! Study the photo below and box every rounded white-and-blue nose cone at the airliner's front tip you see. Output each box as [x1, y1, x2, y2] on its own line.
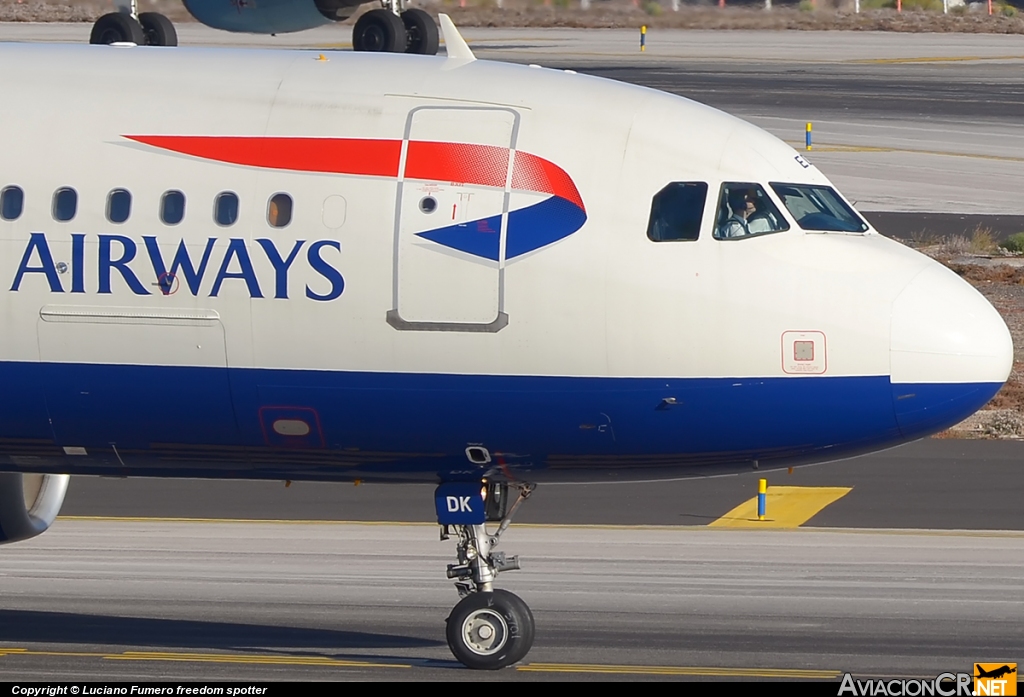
[890, 263, 1014, 438]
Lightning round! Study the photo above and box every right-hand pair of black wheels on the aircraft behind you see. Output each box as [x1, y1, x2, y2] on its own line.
[352, 0, 440, 55]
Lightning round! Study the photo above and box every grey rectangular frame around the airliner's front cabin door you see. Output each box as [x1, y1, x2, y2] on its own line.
[387, 105, 519, 334]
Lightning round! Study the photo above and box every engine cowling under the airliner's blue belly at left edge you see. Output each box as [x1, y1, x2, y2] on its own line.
[0, 472, 71, 544]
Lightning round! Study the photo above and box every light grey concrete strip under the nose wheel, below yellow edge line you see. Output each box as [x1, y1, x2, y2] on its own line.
[0, 521, 1024, 681]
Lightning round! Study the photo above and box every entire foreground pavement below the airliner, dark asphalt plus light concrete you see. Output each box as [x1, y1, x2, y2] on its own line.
[0, 433, 1011, 681]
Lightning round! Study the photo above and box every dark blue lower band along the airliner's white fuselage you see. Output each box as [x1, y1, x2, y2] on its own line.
[0, 362, 1000, 479]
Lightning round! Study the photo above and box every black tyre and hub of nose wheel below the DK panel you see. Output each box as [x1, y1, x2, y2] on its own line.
[444, 591, 534, 670]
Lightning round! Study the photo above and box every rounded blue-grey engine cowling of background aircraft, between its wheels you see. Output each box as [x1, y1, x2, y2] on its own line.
[184, 0, 361, 34]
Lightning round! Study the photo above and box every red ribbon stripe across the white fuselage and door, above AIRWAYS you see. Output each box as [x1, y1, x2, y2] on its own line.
[125, 135, 586, 210]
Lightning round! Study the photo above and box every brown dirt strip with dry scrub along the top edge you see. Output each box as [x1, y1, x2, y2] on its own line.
[0, 0, 1024, 34]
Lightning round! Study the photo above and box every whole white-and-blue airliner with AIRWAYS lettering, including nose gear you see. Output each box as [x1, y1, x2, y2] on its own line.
[0, 18, 1013, 668]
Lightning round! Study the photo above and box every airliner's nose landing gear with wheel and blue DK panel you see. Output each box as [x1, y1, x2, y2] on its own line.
[434, 482, 534, 670]
